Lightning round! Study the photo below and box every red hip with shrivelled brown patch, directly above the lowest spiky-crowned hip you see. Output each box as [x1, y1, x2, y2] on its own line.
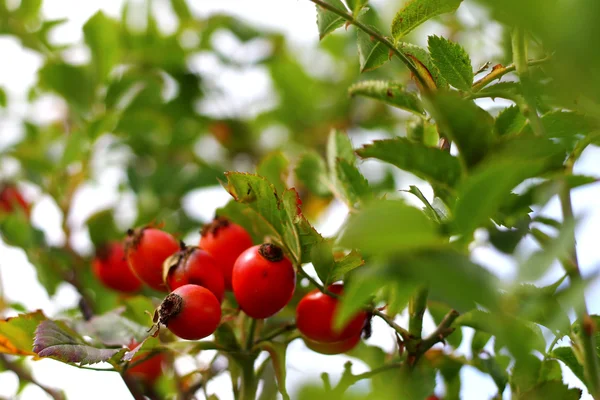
[164, 246, 225, 302]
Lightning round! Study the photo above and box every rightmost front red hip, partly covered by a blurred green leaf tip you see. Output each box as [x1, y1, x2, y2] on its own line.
[296, 284, 367, 343]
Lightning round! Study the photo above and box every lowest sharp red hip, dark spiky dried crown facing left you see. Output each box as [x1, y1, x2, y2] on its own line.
[158, 285, 221, 340]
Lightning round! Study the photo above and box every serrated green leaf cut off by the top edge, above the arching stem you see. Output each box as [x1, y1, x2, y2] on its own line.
[392, 0, 462, 41]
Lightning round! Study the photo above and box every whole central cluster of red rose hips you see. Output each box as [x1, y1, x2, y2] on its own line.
[93, 217, 367, 360]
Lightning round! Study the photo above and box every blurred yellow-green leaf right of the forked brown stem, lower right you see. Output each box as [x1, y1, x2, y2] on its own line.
[454, 310, 546, 358]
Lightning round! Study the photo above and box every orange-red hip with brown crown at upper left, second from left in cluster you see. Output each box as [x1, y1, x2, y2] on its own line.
[125, 228, 179, 292]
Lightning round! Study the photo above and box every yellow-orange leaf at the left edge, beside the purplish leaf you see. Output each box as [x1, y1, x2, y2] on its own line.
[0, 310, 46, 357]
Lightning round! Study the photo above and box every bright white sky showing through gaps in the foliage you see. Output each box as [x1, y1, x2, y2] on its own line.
[0, 0, 600, 400]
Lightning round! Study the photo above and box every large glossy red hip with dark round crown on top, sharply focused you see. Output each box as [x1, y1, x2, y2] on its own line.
[232, 244, 296, 319]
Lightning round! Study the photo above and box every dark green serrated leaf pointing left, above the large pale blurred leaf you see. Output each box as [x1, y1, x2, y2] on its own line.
[357, 137, 462, 187]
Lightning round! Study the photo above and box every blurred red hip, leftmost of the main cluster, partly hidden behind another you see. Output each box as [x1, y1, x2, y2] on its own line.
[92, 242, 142, 293]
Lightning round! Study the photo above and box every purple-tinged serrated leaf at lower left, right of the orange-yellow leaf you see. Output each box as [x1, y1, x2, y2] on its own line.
[33, 320, 125, 365]
